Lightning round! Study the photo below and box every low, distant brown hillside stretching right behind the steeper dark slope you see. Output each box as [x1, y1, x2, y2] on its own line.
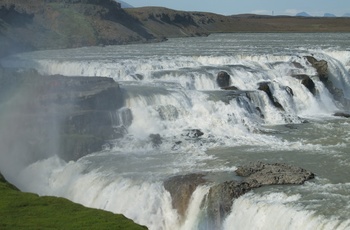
[126, 7, 350, 37]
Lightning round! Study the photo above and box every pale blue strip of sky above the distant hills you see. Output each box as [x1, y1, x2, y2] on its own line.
[123, 0, 350, 16]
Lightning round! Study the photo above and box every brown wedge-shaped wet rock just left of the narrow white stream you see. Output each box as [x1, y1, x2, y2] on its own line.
[164, 174, 206, 217]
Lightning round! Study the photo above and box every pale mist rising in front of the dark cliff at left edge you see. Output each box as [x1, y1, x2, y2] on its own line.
[0, 69, 62, 183]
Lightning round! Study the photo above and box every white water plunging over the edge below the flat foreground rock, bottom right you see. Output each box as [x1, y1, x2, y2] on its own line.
[224, 193, 350, 230]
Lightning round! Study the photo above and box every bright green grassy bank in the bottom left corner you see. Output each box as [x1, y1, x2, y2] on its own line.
[0, 174, 147, 230]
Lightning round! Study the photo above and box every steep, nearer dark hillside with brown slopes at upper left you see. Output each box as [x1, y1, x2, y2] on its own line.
[0, 0, 154, 55]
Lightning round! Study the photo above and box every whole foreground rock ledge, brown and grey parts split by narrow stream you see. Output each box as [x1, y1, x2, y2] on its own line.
[164, 162, 315, 229]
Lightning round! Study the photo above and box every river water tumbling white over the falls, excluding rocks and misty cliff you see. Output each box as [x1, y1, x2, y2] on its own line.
[0, 34, 350, 230]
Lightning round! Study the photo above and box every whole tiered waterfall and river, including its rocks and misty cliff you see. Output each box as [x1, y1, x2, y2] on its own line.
[0, 33, 350, 230]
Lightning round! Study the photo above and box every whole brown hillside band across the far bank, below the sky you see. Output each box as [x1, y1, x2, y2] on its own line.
[0, 0, 350, 57]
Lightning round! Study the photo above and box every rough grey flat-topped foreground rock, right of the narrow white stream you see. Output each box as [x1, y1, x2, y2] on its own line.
[205, 162, 314, 229]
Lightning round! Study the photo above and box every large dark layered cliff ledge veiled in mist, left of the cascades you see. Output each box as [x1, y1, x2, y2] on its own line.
[0, 69, 123, 161]
